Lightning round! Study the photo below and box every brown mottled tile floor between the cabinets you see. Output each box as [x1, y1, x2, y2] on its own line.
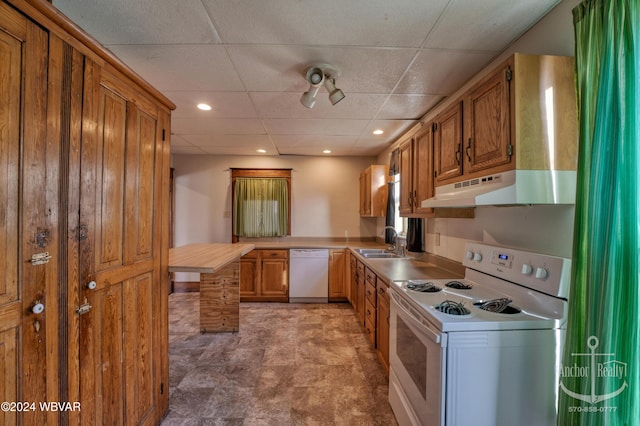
[162, 293, 397, 426]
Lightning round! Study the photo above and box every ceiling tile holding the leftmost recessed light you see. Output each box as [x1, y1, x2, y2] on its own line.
[164, 90, 258, 118]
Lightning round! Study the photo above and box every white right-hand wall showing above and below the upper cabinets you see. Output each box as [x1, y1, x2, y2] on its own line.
[378, 0, 580, 262]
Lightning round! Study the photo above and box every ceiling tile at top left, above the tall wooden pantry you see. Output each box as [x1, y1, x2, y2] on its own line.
[53, 0, 220, 44]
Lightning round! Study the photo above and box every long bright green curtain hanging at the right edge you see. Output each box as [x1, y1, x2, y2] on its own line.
[558, 0, 640, 426]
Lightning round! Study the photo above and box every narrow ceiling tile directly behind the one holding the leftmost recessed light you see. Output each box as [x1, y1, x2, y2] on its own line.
[171, 118, 266, 135]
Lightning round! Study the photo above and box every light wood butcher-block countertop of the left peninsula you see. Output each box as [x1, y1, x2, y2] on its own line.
[169, 243, 255, 274]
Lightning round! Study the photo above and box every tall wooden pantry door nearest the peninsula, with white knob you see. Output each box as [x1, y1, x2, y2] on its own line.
[78, 60, 168, 425]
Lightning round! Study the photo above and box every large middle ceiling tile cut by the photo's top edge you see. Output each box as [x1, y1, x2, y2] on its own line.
[204, 0, 447, 47]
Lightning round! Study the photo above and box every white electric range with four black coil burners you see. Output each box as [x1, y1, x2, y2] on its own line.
[389, 243, 571, 426]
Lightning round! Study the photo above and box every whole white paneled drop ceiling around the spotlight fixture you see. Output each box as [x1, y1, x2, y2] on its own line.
[53, 0, 559, 156]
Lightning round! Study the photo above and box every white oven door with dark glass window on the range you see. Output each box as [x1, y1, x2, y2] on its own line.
[389, 290, 447, 426]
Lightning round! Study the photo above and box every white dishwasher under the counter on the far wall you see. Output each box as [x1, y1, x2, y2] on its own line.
[289, 249, 329, 303]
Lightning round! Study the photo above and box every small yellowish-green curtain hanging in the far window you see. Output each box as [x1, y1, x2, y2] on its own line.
[233, 178, 289, 237]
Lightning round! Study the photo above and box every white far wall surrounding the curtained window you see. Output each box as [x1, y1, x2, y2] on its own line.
[172, 155, 376, 246]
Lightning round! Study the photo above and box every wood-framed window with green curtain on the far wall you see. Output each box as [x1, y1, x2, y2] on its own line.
[231, 169, 291, 242]
